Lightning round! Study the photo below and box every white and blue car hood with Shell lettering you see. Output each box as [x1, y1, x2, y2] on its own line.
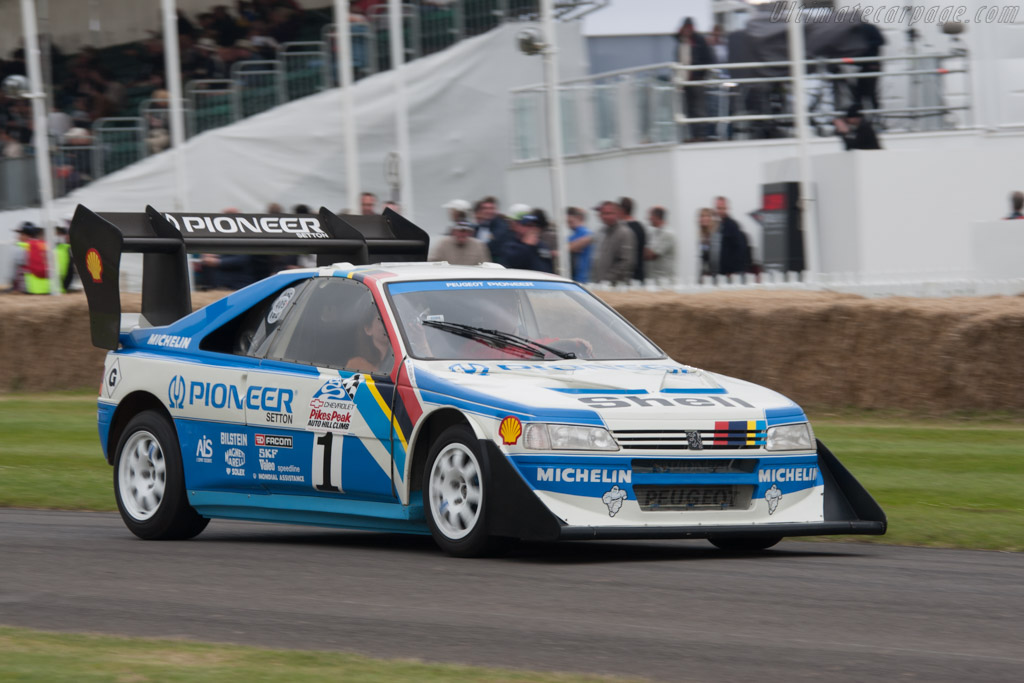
[403, 359, 804, 426]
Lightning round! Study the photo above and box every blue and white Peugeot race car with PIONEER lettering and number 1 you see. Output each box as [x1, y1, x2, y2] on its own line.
[71, 207, 886, 556]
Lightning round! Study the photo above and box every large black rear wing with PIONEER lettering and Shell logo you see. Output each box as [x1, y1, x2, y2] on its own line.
[70, 205, 430, 349]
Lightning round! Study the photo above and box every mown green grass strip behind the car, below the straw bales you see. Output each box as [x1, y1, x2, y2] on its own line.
[0, 393, 1024, 551]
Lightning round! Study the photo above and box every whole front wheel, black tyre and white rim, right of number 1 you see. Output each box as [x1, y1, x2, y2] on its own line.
[423, 425, 492, 557]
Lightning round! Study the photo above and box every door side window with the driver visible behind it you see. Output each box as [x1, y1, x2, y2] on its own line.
[266, 278, 394, 374]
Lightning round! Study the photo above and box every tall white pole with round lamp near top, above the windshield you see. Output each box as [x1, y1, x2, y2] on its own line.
[541, 0, 572, 278]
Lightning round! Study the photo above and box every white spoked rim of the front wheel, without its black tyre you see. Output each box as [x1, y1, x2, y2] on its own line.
[427, 442, 483, 541]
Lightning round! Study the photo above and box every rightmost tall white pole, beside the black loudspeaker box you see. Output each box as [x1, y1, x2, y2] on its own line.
[786, 4, 820, 278]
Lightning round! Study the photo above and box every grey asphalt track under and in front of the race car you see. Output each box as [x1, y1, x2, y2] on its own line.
[0, 509, 1024, 682]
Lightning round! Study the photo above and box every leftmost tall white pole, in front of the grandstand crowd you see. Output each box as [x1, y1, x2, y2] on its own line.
[22, 0, 60, 296]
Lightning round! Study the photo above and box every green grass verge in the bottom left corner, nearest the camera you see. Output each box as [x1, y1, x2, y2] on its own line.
[0, 627, 624, 683]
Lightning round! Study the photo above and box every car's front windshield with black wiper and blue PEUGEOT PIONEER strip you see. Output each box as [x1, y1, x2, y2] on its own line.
[388, 280, 665, 360]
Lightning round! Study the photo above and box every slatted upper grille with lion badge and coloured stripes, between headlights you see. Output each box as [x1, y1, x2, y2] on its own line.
[612, 420, 768, 452]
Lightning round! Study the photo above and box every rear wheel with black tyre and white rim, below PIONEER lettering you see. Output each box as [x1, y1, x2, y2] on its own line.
[114, 411, 210, 541]
